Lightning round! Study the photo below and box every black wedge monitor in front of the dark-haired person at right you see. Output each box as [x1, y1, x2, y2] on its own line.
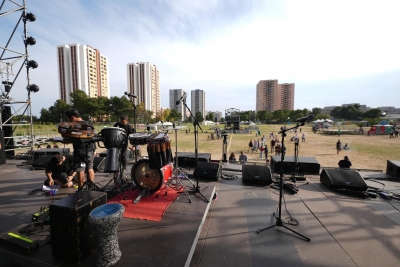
[320, 169, 368, 191]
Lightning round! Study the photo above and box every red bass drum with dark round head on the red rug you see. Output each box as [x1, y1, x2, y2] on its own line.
[131, 159, 173, 193]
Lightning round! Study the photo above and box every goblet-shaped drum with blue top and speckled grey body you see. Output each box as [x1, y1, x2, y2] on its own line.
[89, 203, 125, 267]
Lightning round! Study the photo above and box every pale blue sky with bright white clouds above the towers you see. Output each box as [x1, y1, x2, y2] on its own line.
[0, 0, 400, 116]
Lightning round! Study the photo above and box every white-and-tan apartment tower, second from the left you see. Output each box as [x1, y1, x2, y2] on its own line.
[127, 62, 161, 117]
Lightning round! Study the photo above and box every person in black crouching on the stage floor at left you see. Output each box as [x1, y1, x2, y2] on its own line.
[44, 154, 76, 187]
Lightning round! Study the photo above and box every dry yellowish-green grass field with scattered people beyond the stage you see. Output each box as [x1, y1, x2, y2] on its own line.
[25, 124, 400, 171]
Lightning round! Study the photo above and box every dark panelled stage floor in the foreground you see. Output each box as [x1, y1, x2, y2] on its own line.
[0, 160, 400, 267]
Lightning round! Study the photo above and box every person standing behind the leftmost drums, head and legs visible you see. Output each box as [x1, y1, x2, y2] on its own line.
[66, 108, 96, 187]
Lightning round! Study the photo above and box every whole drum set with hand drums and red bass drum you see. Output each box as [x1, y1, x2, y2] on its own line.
[52, 122, 195, 203]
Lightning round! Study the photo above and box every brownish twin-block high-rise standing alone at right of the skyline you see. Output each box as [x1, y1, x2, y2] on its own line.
[256, 80, 295, 112]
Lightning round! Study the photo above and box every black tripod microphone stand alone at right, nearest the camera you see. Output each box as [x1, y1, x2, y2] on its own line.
[257, 122, 311, 242]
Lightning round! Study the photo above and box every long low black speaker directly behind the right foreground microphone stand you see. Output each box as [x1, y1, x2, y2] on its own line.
[271, 156, 321, 175]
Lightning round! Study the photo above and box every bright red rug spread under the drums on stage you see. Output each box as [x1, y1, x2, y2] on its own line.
[107, 188, 179, 222]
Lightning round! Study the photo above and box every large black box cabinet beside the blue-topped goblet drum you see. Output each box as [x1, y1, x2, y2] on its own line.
[50, 191, 107, 264]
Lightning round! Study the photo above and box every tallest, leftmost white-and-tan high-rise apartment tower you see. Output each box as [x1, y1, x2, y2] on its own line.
[57, 44, 110, 104]
